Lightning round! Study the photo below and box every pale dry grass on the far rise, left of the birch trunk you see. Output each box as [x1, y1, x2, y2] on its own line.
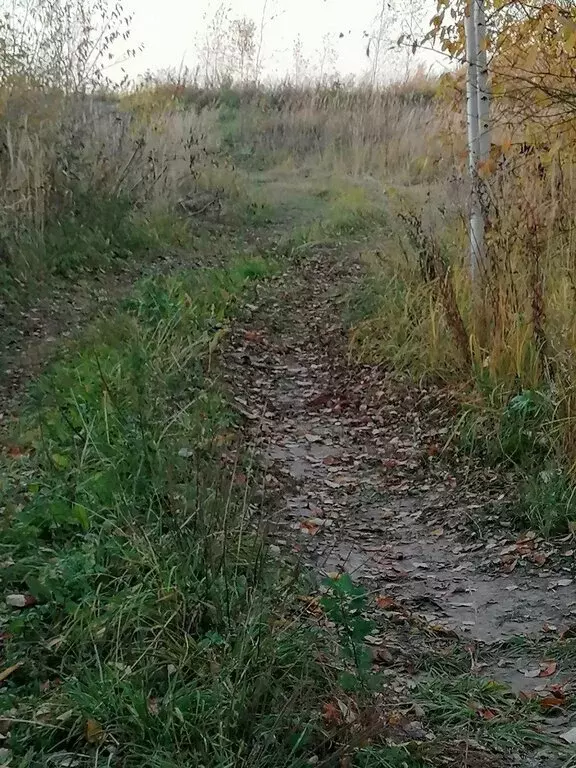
[215, 83, 450, 182]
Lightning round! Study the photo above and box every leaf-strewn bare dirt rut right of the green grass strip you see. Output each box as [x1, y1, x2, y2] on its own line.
[228, 252, 576, 690]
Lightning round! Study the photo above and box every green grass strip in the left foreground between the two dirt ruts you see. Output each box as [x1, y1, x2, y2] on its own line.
[0, 254, 346, 767]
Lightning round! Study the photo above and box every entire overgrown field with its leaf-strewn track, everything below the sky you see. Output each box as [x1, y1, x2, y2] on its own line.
[0, 34, 576, 768]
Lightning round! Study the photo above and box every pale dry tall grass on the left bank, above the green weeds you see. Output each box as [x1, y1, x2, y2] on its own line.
[0, 99, 223, 230]
